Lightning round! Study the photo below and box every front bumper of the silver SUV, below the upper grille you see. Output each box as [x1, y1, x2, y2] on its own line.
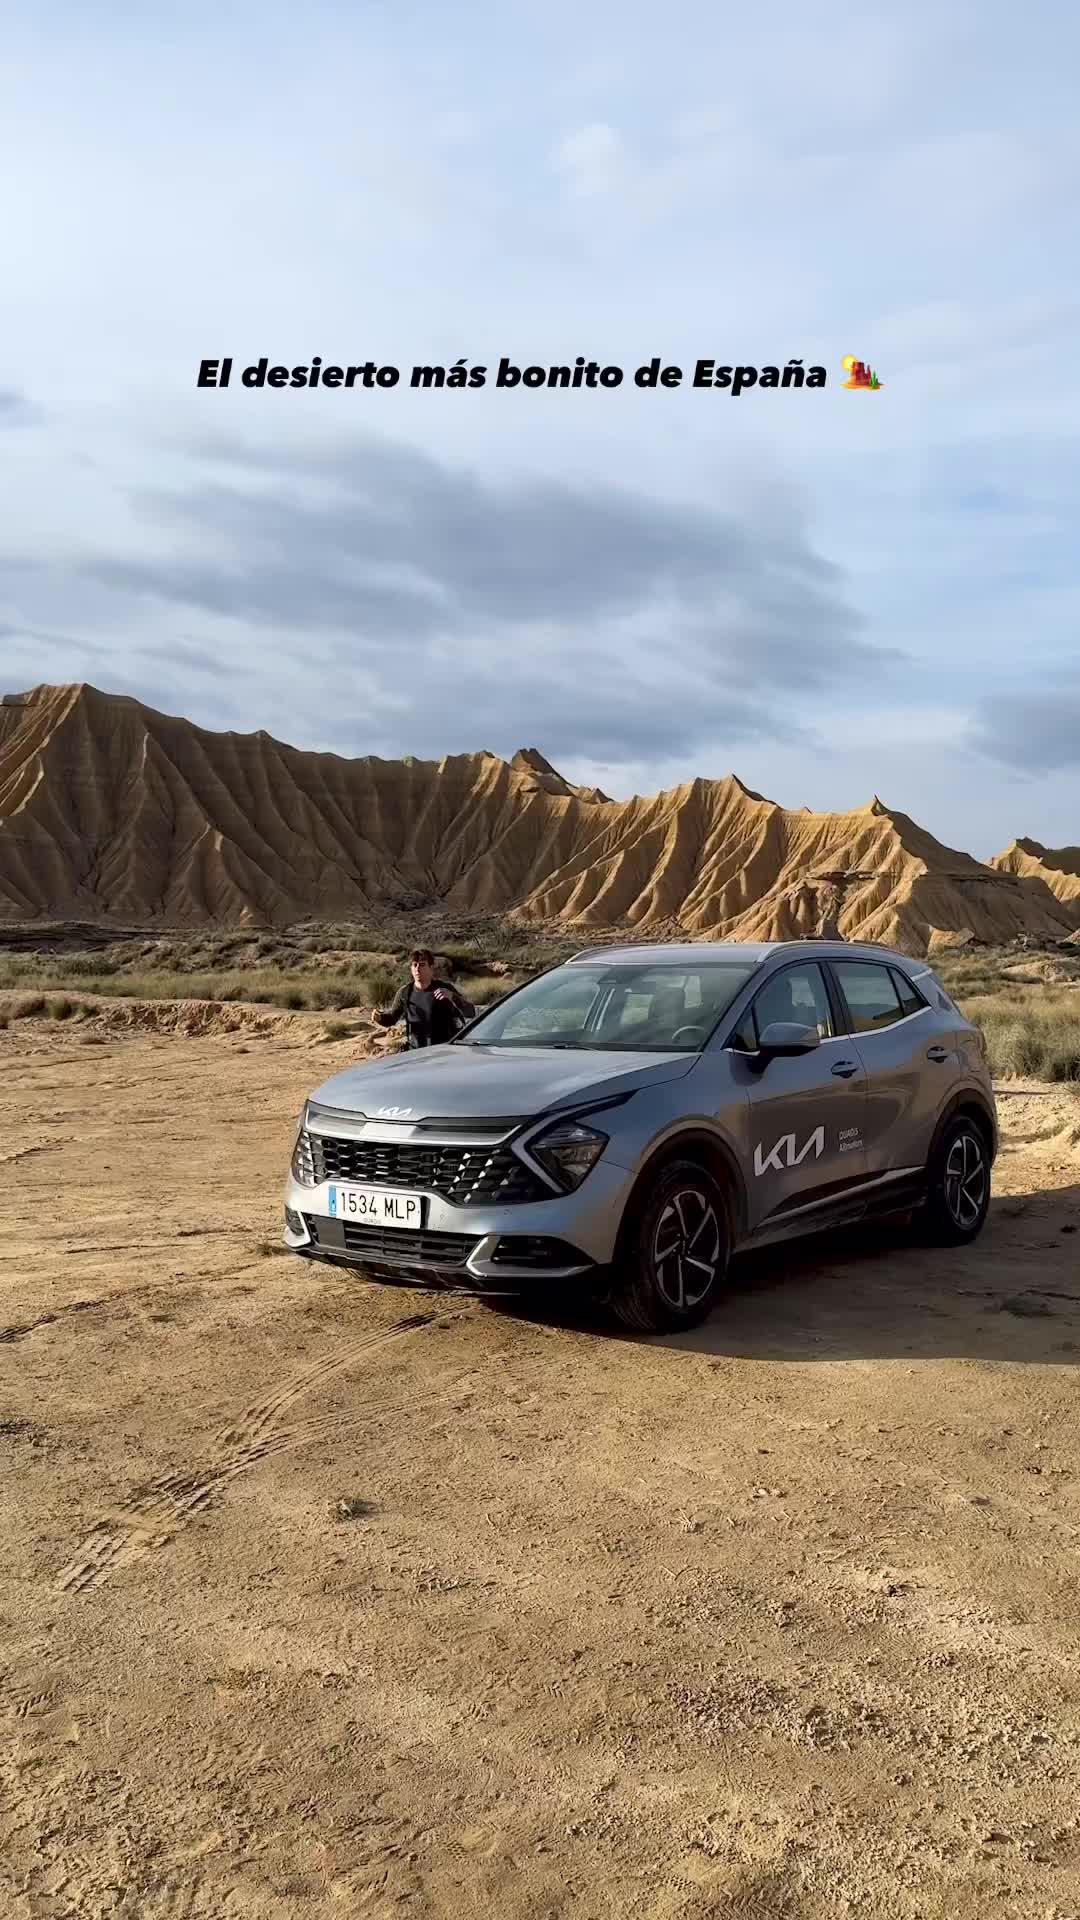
[284, 1162, 630, 1294]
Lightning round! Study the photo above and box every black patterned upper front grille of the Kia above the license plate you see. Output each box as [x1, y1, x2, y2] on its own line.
[311, 1133, 552, 1206]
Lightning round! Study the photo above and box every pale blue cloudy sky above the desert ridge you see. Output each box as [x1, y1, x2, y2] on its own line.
[0, 0, 1080, 858]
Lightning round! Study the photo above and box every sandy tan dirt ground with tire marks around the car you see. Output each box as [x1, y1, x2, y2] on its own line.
[0, 1016, 1080, 1920]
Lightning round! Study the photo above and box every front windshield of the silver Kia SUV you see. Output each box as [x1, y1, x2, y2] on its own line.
[454, 960, 753, 1054]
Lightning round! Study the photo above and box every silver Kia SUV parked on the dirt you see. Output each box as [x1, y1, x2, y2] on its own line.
[284, 941, 997, 1332]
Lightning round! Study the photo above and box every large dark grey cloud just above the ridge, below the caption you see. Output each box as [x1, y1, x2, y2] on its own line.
[52, 442, 891, 760]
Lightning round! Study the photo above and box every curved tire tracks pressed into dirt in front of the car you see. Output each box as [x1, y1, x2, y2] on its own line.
[56, 1311, 463, 1594]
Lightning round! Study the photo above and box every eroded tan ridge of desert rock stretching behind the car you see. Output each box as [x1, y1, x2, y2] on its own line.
[0, 685, 1080, 952]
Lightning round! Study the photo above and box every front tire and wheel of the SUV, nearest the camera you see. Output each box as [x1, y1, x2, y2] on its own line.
[607, 1160, 730, 1332]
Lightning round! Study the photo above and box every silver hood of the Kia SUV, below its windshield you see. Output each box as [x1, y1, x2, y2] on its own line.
[311, 1046, 698, 1121]
